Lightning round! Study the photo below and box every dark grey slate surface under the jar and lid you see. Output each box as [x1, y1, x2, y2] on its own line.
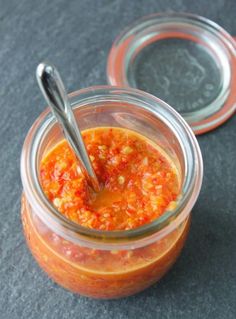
[0, 0, 236, 319]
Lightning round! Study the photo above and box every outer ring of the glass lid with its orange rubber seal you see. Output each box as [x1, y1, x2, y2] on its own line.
[107, 12, 236, 134]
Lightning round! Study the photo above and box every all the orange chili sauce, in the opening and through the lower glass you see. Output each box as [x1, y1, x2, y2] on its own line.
[22, 128, 189, 298]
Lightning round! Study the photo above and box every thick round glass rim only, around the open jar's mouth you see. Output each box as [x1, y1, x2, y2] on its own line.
[21, 86, 203, 247]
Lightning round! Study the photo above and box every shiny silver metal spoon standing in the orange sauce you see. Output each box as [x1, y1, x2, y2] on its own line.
[36, 63, 100, 192]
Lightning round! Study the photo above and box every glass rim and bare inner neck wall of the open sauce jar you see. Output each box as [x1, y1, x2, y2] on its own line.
[21, 86, 202, 249]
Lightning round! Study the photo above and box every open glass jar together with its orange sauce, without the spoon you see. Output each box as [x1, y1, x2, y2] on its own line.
[21, 86, 203, 299]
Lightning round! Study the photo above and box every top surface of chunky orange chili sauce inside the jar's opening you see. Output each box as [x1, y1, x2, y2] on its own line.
[40, 128, 179, 230]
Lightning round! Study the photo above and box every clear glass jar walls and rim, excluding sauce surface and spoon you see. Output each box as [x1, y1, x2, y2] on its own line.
[21, 86, 203, 299]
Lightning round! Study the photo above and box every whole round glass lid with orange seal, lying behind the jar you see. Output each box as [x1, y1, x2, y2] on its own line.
[107, 13, 236, 134]
